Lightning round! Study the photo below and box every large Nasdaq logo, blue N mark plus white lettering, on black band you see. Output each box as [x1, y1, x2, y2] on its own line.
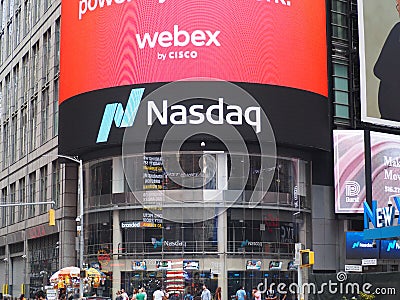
[96, 88, 261, 143]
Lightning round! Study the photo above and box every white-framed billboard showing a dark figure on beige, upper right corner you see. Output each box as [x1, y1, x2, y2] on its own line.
[358, 0, 400, 127]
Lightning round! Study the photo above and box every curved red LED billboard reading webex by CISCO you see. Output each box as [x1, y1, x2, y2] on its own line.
[60, 0, 327, 103]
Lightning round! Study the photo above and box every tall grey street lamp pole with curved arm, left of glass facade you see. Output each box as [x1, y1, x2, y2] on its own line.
[45, 154, 84, 299]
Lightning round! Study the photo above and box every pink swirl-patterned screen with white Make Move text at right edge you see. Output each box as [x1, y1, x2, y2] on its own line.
[371, 132, 400, 207]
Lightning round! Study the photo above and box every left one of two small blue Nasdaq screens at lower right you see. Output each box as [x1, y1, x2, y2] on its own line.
[346, 232, 380, 259]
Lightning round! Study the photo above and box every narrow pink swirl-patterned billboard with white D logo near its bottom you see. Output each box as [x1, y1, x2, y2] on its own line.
[333, 130, 366, 213]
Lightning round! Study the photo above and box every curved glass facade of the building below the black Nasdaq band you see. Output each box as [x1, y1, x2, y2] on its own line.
[84, 152, 311, 297]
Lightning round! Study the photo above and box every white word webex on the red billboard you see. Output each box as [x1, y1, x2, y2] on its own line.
[136, 25, 221, 49]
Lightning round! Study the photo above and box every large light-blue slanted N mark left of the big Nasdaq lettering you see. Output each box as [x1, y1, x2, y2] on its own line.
[96, 88, 144, 143]
